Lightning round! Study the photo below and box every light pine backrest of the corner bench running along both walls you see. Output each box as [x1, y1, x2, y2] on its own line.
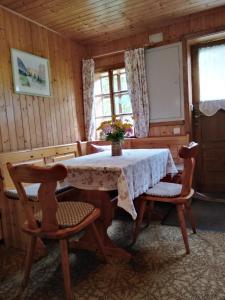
[0, 135, 189, 189]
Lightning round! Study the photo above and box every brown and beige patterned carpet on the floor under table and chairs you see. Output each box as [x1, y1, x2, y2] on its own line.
[0, 220, 225, 300]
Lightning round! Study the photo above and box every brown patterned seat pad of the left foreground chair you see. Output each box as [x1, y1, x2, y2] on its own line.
[35, 202, 95, 228]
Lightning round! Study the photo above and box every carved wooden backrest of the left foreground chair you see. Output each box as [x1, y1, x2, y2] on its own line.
[7, 163, 67, 232]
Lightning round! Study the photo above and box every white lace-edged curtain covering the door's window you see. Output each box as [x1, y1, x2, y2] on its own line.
[198, 45, 225, 116]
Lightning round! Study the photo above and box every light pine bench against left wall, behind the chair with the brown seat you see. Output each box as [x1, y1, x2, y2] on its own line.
[0, 143, 80, 249]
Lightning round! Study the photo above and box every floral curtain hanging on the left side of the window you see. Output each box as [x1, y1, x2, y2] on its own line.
[82, 59, 96, 140]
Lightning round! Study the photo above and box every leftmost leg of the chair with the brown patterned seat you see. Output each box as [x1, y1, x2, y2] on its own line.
[22, 236, 37, 289]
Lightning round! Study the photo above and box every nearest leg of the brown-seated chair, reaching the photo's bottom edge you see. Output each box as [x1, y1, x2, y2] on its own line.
[59, 239, 74, 300]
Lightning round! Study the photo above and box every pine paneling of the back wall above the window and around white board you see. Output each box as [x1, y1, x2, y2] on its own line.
[91, 7, 225, 136]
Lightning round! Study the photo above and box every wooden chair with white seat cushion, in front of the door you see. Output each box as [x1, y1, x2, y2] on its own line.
[133, 142, 198, 254]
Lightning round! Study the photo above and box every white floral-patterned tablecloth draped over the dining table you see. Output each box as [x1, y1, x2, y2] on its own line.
[61, 149, 177, 219]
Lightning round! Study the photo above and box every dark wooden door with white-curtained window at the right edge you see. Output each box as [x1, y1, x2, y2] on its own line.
[192, 42, 225, 193]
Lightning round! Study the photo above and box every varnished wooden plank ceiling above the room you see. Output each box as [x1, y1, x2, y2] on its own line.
[0, 0, 225, 44]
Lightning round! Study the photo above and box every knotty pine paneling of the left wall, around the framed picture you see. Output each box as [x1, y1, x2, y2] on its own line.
[0, 8, 85, 152]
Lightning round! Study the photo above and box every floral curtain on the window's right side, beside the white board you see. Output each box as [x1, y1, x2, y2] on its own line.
[125, 48, 150, 137]
